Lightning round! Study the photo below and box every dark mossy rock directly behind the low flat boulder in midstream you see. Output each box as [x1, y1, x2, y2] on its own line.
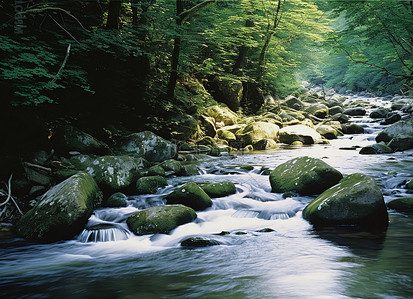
[166, 182, 212, 211]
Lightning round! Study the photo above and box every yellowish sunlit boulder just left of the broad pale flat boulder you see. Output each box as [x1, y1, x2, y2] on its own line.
[236, 122, 280, 144]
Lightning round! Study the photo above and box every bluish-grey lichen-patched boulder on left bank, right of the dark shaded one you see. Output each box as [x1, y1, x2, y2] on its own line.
[114, 131, 177, 162]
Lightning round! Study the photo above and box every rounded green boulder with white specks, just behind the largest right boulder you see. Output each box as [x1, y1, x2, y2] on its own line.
[270, 157, 343, 195]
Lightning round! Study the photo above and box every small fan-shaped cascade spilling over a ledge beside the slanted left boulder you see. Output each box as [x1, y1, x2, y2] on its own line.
[78, 223, 130, 243]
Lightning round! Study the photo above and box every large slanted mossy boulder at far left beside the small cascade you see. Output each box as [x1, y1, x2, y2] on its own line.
[16, 172, 102, 242]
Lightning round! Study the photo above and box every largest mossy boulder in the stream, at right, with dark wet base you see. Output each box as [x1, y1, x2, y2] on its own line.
[303, 173, 389, 229]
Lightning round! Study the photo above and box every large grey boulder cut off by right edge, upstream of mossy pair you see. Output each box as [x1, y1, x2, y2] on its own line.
[376, 117, 413, 151]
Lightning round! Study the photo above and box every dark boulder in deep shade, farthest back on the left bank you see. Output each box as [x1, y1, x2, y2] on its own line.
[52, 125, 112, 155]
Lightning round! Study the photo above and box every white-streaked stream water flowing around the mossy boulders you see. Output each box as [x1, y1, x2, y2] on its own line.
[0, 98, 413, 298]
